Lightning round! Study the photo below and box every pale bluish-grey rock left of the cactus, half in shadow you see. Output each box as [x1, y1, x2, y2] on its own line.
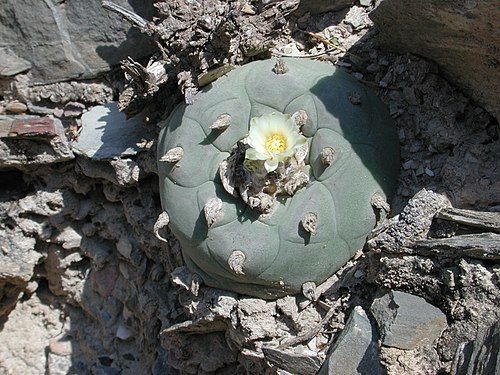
[72, 103, 151, 160]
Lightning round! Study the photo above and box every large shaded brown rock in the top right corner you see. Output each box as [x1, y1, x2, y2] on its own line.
[370, 0, 500, 119]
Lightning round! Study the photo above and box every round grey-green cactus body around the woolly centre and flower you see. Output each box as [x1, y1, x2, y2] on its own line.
[158, 59, 399, 298]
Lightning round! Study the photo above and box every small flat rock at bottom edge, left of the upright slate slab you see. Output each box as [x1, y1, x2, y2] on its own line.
[262, 347, 319, 375]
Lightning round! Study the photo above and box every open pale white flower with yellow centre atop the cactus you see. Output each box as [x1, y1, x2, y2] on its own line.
[245, 112, 307, 172]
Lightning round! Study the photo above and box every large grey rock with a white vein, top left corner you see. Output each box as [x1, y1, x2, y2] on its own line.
[0, 0, 153, 84]
